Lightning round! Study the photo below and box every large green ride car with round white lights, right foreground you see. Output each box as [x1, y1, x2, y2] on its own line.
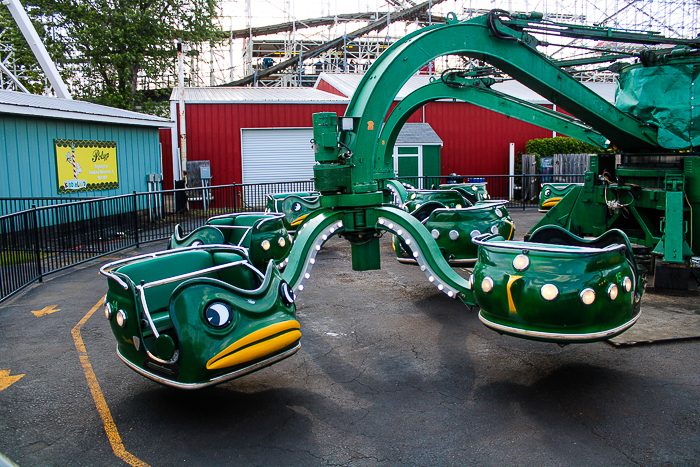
[472, 226, 645, 344]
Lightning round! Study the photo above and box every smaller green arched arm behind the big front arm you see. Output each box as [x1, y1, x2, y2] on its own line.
[375, 80, 607, 173]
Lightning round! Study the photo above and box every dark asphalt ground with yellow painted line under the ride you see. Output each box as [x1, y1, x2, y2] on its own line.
[0, 211, 700, 466]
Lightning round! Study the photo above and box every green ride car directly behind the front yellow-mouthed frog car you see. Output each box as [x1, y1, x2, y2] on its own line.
[168, 212, 292, 269]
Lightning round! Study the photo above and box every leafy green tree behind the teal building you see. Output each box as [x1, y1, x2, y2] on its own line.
[2, 0, 217, 109]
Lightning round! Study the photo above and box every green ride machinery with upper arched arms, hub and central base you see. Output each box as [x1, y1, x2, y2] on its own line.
[314, 10, 700, 288]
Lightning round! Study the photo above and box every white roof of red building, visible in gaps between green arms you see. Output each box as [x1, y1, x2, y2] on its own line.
[315, 72, 617, 104]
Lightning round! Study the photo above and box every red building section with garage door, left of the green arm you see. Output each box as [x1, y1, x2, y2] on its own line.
[161, 87, 348, 189]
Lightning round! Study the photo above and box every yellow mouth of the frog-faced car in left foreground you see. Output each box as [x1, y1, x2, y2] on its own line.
[207, 320, 301, 370]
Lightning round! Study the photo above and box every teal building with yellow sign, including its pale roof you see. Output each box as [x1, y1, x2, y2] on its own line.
[0, 91, 173, 198]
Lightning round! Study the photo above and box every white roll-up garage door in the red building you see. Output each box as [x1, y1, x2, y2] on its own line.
[241, 128, 316, 183]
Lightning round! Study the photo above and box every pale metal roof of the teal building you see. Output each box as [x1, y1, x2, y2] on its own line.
[0, 90, 173, 127]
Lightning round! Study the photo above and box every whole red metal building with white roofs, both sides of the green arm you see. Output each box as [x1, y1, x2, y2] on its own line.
[161, 73, 614, 188]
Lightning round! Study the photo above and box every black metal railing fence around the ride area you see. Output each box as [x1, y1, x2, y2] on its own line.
[0, 176, 580, 301]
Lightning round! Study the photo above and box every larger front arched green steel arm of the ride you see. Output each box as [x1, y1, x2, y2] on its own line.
[340, 15, 658, 193]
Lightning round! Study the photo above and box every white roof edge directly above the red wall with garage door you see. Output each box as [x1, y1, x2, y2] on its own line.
[170, 86, 349, 104]
